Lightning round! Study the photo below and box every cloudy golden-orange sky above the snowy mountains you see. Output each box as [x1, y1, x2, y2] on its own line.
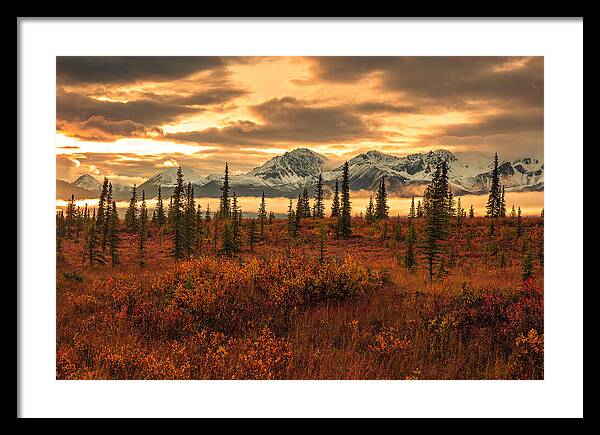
[56, 57, 544, 184]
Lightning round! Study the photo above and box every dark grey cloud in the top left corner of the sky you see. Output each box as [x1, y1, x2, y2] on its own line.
[56, 56, 225, 84]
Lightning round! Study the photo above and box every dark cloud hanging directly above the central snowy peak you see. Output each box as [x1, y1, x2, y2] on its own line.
[165, 97, 376, 146]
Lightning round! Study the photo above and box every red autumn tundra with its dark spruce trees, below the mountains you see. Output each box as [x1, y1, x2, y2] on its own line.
[56, 156, 544, 380]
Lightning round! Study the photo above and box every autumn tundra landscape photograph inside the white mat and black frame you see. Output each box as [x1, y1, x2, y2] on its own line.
[55, 56, 544, 381]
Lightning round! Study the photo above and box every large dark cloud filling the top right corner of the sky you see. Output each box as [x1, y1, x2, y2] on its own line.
[313, 56, 544, 106]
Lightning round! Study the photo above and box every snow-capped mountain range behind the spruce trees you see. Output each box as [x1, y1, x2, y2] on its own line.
[57, 148, 544, 199]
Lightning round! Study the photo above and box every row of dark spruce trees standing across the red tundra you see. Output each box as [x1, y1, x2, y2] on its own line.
[56, 154, 543, 280]
